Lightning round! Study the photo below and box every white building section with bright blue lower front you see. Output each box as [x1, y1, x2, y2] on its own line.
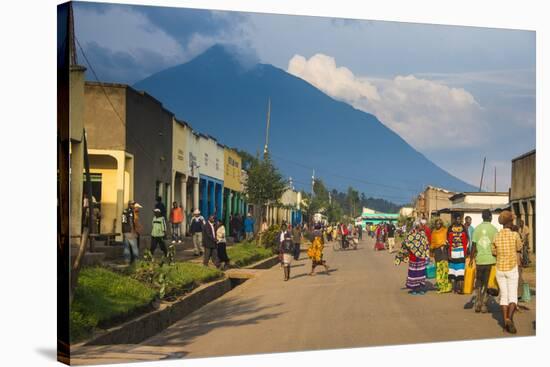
[198, 133, 224, 220]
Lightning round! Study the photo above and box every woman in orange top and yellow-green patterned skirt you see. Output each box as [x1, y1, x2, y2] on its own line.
[430, 218, 451, 293]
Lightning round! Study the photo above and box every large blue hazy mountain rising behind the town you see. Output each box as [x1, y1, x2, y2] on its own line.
[134, 45, 475, 203]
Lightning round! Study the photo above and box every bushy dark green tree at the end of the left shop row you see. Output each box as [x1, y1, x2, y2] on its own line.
[245, 154, 287, 227]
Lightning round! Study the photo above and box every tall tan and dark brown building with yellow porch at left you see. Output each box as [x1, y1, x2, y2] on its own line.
[84, 82, 173, 241]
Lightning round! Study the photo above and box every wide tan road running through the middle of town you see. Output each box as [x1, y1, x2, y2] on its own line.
[72, 239, 535, 364]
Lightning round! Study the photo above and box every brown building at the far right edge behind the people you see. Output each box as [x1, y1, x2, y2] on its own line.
[510, 150, 537, 252]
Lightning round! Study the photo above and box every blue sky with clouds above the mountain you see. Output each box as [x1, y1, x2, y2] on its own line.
[75, 3, 536, 191]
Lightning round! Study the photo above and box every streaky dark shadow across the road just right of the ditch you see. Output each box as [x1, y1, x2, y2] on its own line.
[142, 297, 283, 347]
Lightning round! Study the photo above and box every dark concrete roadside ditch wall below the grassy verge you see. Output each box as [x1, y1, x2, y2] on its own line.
[75, 277, 231, 352]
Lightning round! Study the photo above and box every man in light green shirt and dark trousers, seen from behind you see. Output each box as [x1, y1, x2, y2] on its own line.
[470, 209, 498, 313]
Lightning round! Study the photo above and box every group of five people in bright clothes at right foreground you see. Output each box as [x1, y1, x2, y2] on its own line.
[395, 210, 529, 334]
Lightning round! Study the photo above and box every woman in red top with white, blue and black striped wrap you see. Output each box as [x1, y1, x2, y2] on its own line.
[447, 214, 468, 294]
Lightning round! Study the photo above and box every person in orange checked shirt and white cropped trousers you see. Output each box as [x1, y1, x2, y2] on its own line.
[492, 210, 522, 334]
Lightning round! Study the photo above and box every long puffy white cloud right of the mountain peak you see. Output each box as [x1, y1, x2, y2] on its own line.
[288, 54, 486, 151]
